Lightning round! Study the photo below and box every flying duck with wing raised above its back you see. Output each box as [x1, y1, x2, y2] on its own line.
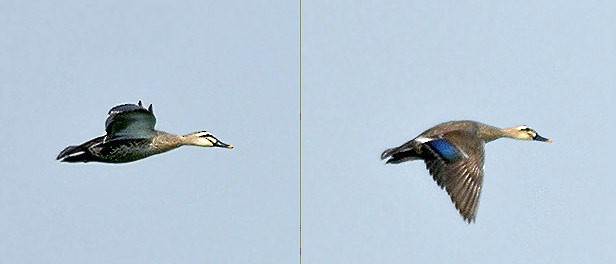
[56, 101, 233, 163]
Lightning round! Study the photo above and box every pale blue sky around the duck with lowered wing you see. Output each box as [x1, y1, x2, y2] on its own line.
[302, 0, 616, 263]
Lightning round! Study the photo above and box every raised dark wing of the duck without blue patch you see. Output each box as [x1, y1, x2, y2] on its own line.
[104, 101, 156, 142]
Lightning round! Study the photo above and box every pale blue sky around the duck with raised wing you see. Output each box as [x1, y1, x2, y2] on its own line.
[0, 1, 299, 263]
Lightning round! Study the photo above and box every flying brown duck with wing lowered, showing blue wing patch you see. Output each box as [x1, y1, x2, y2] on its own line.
[381, 120, 552, 224]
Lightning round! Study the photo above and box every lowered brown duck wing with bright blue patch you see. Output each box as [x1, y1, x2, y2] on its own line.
[422, 131, 484, 223]
